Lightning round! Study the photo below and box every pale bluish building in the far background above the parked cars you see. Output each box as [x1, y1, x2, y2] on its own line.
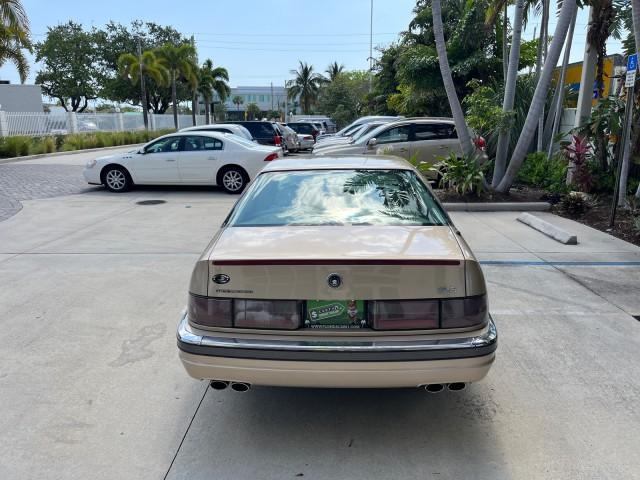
[198, 85, 297, 120]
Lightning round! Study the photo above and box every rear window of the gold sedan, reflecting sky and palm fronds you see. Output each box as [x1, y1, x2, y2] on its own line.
[227, 170, 448, 227]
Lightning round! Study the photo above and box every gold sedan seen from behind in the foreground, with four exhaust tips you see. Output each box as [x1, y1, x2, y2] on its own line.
[177, 156, 497, 392]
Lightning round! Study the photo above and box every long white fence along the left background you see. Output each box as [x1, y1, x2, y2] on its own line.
[0, 111, 205, 137]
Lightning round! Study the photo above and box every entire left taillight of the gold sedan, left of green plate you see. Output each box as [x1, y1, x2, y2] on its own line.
[187, 294, 302, 330]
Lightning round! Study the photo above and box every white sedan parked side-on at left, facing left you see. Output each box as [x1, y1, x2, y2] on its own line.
[83, 131, 282, 193]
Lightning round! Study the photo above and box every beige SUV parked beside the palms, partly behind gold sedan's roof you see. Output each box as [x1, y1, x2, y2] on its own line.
[314, 118, 486, 170]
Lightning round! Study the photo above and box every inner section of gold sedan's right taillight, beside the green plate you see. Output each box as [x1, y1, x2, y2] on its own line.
[369, 300, 439, 330]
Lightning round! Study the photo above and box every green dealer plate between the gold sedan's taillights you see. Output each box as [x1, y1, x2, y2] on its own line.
[305, 300, 366, 328]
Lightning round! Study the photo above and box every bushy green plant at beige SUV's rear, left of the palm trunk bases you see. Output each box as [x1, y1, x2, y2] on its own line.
[430, 152, 485, 195]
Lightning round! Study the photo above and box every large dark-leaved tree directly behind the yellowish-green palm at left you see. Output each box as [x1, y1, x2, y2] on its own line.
[93, 20, 191, 113]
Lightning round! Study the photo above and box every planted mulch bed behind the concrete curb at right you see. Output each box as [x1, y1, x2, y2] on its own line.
[434, 185, 640, 246]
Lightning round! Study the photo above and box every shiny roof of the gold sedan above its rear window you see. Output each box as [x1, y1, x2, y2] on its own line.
[262, 155, 413, 172]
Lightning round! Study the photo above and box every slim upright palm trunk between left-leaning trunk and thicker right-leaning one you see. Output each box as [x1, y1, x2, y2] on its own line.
[491, 0, 524, 188]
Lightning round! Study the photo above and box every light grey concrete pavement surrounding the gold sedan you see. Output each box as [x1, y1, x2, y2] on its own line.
[0, 148, 640, 480]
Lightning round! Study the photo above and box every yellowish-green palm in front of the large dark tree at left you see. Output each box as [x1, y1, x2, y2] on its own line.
[118, 51, 169, 129]
